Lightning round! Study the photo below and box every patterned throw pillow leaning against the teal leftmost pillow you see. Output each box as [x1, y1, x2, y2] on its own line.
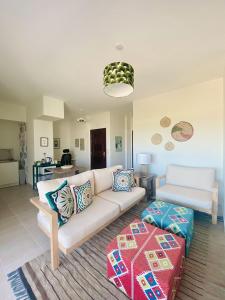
[70, 180, 93, 214]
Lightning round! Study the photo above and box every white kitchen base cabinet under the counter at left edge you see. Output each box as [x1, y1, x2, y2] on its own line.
[0, 161, 19, 188]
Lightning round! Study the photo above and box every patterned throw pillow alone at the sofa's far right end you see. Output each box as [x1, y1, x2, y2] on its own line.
[112, 170, 132, 192]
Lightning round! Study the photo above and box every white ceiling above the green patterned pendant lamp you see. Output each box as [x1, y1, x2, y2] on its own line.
[0, 0, 225, 112]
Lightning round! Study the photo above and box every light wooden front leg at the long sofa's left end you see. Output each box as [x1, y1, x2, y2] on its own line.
[50, 216, 59, 271]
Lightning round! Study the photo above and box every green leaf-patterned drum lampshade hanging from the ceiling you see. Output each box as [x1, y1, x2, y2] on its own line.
[104, 62, 134, 97]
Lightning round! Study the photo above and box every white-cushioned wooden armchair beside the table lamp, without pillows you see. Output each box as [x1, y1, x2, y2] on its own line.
[156, 165, 218, 224]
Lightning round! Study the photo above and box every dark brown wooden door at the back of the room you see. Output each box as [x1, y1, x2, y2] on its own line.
[90, 128, 106, 169]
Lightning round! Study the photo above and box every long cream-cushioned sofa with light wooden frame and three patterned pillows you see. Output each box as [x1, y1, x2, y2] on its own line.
[31, 166, 145, 269]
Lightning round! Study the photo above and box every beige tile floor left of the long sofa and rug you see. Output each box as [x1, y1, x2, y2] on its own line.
[0, 185, 49, 300]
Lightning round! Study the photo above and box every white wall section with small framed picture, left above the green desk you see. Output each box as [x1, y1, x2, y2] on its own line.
[33, 120, 53, 161]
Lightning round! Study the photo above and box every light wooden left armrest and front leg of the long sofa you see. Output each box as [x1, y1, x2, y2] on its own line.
[30, 197, 59, 270]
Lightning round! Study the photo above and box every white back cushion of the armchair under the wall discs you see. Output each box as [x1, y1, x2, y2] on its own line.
[166, 165, 215, 191]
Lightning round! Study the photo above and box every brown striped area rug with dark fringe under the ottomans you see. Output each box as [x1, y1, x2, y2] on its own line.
[8, 202, 225, 300]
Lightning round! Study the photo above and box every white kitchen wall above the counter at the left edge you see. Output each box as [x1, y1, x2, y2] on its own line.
[0, 120, 20, 160]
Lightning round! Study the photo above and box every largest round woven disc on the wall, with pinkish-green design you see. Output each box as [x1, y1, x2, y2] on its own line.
[171, 121, 194, 142]
